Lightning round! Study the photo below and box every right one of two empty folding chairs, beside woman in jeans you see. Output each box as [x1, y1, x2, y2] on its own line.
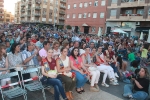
[21, 67, 46, 100]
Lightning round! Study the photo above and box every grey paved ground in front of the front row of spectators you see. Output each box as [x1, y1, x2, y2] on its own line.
[0, 63, 150, 100]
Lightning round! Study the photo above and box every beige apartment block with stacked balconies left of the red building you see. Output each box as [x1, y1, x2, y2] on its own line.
[17, 0, 66, 25]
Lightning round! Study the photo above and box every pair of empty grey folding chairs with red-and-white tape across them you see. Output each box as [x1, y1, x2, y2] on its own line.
[0, 66, 51, 100]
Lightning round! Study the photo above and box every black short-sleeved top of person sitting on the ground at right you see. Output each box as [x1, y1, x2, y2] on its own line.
[134, 78, 149, 93]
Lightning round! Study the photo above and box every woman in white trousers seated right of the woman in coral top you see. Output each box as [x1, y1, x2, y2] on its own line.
[82, 46, 100, 92]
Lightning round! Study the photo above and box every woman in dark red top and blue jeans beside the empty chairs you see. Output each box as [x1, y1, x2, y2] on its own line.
[41, 49, 68, 100]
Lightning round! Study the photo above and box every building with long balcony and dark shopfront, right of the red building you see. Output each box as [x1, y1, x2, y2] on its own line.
[106, 0, 150, 36]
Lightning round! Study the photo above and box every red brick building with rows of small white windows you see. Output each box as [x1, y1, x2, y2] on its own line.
[65, 0, 109, 34]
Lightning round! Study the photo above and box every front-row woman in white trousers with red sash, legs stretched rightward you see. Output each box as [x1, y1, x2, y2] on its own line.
[96, 46, 119, 87]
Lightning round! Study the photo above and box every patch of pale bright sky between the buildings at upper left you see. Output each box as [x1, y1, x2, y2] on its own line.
[4, 0, 19, 14]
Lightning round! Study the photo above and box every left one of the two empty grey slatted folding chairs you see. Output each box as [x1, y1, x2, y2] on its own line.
[0, 72, 27, 100]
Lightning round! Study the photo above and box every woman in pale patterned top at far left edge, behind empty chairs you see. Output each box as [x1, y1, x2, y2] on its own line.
[0, 44, 11, 86]
